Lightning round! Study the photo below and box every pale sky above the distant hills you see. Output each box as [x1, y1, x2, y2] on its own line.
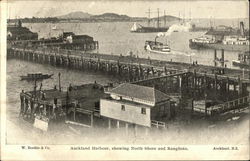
[7, 0, 249, 18]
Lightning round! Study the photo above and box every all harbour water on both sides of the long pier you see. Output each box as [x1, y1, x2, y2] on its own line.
[7, 22, 248, 144]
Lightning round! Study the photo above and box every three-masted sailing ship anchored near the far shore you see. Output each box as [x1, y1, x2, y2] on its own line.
[130, 9, 169, 33]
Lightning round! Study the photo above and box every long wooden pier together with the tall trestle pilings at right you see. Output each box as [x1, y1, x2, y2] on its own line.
[7, 47, 250, 117]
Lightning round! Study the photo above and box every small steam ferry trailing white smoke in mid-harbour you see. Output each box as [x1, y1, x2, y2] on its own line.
[144, 41, 171, 54]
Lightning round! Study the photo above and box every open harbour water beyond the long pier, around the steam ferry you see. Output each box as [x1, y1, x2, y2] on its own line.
[23, 22, 238, 67]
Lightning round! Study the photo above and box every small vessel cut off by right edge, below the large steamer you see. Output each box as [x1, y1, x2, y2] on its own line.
[232, 51, 250, 69]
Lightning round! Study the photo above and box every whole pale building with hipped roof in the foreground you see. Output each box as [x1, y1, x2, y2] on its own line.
[100, 83, 174, 127]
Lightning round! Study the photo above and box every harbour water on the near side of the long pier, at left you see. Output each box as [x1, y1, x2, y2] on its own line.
[6, 60, 117, 144]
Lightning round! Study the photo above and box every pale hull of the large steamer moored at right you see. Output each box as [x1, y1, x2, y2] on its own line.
[189, 40, 249, 52]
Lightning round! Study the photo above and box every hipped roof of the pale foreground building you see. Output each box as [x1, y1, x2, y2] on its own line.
[110, 83, 170, 103]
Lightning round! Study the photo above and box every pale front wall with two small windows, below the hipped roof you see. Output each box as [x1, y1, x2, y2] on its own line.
[100, 99, 151, 127]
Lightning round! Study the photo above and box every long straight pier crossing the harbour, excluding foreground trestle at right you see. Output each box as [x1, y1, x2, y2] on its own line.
[7, 47, 250, 82]
